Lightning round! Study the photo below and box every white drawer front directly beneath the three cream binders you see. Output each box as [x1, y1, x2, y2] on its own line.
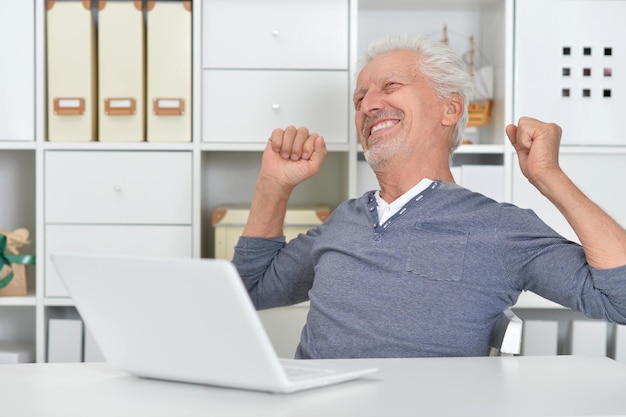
[45, 151, 192, 224]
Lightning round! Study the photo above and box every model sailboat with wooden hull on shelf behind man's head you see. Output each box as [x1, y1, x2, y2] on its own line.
[443, 25, 493, 127]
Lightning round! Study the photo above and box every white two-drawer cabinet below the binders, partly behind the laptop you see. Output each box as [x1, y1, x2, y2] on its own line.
[44, 150, 193, 297]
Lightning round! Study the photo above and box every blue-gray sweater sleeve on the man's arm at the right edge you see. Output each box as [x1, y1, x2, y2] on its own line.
[498, 205, 626, 324]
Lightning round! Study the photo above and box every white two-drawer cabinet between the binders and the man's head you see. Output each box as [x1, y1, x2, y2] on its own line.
[202, 0, 351, 145]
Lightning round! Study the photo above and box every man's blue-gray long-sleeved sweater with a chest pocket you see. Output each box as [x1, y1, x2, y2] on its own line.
[233, 181, 626, 358]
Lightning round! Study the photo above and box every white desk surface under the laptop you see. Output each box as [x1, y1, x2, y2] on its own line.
[0, 356, 626, 417]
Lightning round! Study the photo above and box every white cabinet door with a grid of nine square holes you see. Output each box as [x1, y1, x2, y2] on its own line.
[514, 0, 626, 145]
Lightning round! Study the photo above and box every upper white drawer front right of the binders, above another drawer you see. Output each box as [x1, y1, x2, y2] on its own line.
[202, 0, 349, 70]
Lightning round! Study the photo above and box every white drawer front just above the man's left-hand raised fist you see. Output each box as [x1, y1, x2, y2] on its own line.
[202, 70, 350, 143]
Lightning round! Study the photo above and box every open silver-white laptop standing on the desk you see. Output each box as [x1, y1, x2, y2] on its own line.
[51, 253, 376, 393]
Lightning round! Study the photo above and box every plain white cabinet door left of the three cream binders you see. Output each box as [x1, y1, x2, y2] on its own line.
[0, 1, 35, 141]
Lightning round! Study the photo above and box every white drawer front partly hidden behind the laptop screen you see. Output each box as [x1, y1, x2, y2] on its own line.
[44, 225, 192, 297]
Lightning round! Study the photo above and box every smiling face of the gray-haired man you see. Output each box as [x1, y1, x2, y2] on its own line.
[354, 51, 442, 169]
